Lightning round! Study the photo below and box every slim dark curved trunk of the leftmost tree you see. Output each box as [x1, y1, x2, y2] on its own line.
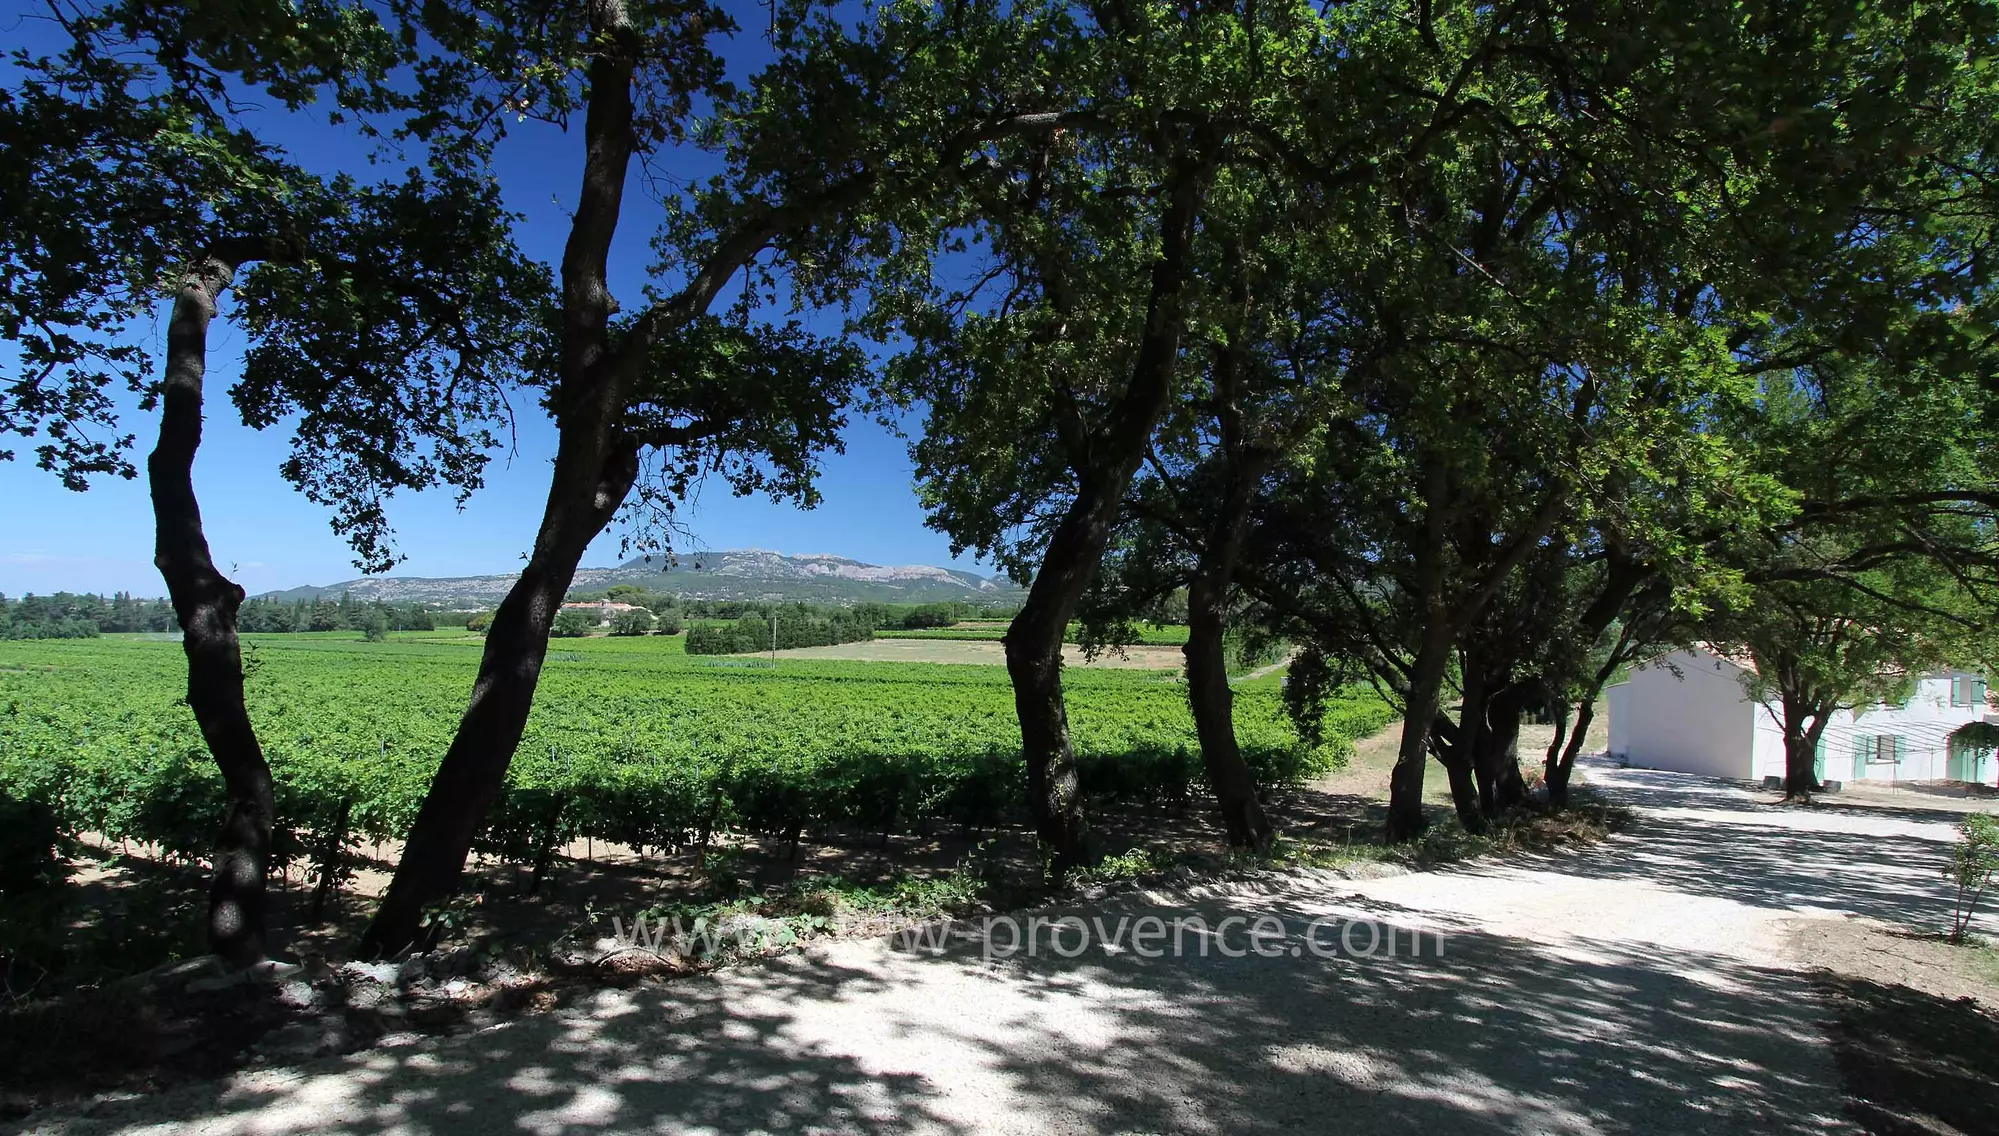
[146, 256, 276, 966]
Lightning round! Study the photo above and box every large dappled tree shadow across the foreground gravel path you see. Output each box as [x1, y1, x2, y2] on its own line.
[19, 880, 1839, 1136]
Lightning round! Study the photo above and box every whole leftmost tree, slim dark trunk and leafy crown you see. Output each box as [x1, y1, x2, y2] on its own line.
[0, 2, 547, 962]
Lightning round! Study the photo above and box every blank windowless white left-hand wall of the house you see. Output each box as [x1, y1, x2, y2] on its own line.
[1609, 650, 1757, 778]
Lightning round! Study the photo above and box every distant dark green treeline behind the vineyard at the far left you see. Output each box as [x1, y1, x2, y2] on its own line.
[0, 592, 449, 640]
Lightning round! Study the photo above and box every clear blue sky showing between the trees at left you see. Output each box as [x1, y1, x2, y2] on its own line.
[0, 0, 980, 596]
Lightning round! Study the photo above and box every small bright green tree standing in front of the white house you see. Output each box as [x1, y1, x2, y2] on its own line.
[1705, 316, 1999, 798]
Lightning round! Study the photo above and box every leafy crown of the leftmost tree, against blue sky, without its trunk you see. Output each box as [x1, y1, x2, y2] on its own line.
[0, 0, 554, 570]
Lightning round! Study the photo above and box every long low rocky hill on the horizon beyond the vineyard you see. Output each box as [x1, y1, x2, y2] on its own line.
[264, 548, 1025, 608]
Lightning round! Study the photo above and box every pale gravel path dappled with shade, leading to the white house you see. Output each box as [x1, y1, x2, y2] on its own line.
[19, 768, 1983, 1136]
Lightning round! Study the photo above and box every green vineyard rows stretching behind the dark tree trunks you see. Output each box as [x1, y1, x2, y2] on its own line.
[0, 632, 1387, 884]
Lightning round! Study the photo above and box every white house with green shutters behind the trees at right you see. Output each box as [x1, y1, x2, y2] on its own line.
[1607, 648, 1999, 784]
